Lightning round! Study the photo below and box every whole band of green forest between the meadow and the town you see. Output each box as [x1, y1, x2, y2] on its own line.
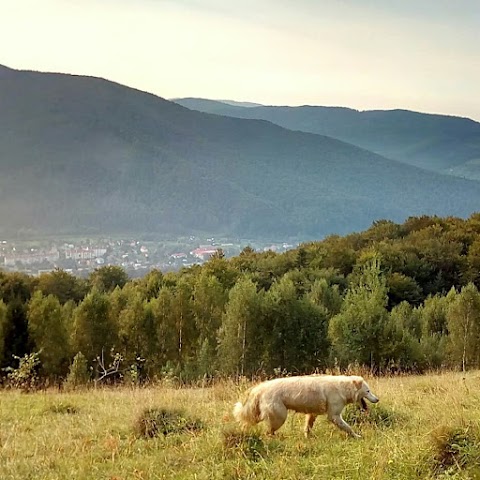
[0, 214, 480, 387]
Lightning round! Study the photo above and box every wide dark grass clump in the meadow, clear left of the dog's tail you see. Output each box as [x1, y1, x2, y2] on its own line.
[134, 408, 203, 438]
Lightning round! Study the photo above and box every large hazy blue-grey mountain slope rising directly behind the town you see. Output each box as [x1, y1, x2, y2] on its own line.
[0, 67, 480, 239]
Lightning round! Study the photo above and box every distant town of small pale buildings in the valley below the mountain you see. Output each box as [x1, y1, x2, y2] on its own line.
[0, 236, 296, 278]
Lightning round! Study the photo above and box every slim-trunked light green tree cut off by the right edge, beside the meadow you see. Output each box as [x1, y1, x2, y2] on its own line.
[447, 283, 480, 371]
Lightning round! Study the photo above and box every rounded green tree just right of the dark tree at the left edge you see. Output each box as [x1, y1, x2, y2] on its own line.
[27, 291, 70, 377]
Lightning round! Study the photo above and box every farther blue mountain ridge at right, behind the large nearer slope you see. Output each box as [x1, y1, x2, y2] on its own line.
[175, 98, 480, 180]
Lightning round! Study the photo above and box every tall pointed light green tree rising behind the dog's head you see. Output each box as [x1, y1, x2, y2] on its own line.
[328, 259, 388, 369]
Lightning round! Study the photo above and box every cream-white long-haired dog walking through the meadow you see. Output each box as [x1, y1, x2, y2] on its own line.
[233, 375, 378, 438]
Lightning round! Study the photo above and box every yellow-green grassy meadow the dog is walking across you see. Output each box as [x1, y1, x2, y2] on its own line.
[0, 372, 480, 480]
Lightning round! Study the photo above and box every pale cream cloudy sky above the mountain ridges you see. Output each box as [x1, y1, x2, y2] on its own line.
[0, 0, 480, 121]
